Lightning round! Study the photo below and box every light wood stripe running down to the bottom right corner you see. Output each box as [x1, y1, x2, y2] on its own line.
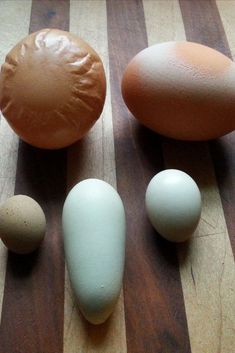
[144, 1, 235, 353]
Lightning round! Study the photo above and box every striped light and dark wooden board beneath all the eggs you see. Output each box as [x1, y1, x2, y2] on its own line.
[0, 0, 235, 353]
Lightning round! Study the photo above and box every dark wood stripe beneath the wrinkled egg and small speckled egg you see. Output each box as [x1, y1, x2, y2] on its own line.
[0, 1, 69, 353]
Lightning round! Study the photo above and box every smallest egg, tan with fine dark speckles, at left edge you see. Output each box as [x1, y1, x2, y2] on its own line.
[0, 195, 46, 254]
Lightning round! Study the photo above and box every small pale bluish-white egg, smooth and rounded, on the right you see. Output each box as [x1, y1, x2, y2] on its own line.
[145, 169, 201, 242]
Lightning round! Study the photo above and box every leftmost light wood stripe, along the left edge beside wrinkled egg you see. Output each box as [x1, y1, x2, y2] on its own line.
[0, 0, 31, 321]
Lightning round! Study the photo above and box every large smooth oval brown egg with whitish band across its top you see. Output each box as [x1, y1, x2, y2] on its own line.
[122, 42, 235, 140]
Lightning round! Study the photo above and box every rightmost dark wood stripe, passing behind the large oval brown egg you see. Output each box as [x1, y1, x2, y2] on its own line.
[180, 0, 235, 254]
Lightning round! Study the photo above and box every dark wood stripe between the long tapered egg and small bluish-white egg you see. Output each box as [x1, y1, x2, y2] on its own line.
[107, 0, 190, 353]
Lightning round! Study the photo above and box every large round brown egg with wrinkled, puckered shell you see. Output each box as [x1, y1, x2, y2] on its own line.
[0, 29, 106, 149]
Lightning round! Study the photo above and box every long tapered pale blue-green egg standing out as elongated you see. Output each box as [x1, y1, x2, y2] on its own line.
[62, 179, 125, 324]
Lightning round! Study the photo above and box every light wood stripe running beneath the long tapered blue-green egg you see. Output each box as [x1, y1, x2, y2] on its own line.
[64, 0, 126, 353]
